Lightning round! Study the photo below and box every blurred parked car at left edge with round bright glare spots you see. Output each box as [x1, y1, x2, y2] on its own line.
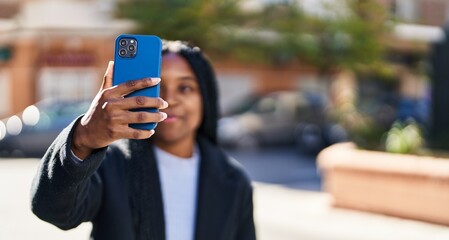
[0, 100, 90, 157]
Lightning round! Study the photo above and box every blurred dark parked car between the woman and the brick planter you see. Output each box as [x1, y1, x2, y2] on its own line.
[218, 91, 347, 153]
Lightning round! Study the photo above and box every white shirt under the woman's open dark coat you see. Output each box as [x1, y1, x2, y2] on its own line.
[154, 146, 200, 240]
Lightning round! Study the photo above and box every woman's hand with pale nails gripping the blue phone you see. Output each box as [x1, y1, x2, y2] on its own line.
[72, 62, 168, 159]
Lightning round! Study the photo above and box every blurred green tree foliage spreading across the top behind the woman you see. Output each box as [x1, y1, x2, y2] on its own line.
[118, 0, 387, 72]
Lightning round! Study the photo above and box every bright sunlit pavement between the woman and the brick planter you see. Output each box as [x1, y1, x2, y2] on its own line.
[254, 183, 449, 240]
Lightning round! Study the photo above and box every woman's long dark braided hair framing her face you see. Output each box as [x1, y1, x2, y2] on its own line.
[162, 40, 219, 143]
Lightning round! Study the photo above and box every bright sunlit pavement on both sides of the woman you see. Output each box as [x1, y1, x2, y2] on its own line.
[0, 159, 449, 240]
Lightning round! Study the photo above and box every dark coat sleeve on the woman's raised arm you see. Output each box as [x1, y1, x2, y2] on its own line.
[31, 119, 106, 230]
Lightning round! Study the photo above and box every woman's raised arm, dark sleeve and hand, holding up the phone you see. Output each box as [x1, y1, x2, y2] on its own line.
[31, 62, 168, 229]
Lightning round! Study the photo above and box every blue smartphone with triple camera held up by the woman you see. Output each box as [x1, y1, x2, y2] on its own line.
[113, 34, 162, 130]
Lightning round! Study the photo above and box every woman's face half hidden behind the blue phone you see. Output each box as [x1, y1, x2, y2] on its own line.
[155, 53, 203, 144]
